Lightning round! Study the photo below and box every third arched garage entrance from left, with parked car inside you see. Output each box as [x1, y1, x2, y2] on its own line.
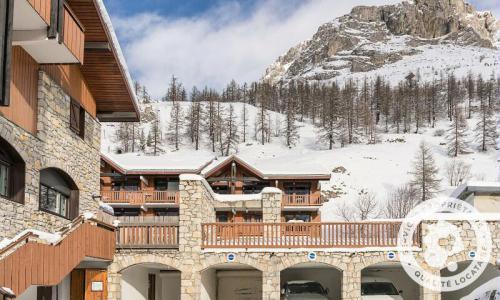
[280, 262, 342, 300]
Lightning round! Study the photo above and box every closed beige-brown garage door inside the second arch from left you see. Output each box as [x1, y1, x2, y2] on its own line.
[217, 271, 262, 300]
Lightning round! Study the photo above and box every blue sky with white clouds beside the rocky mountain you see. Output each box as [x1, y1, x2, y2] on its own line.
[104, 0, 500, 97]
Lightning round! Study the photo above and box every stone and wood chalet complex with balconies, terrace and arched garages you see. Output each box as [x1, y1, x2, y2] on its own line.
[101, 153, 500, 300]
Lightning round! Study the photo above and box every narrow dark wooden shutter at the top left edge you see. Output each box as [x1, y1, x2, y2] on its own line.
[0, 0, 14, 106]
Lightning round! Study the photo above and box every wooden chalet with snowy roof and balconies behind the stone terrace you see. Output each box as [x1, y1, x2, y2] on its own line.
[101, 155, 330, 222]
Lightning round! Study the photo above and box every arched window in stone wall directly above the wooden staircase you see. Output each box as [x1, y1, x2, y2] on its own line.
[39, 168, 79, 220]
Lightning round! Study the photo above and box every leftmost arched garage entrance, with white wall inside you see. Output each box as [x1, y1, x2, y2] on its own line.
[121, 263, 181, 300]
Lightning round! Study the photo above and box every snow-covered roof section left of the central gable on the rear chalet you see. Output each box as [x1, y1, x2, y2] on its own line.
[101, 151, 213, 175]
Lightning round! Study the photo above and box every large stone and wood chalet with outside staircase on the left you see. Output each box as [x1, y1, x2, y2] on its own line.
[0, 0, 139, 300]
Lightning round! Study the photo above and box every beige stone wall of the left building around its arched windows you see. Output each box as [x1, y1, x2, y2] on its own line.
[0, 71, 100, 239]
